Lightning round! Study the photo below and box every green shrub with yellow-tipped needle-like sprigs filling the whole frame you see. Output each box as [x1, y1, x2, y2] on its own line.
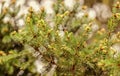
[0, 0, 120, 76]
